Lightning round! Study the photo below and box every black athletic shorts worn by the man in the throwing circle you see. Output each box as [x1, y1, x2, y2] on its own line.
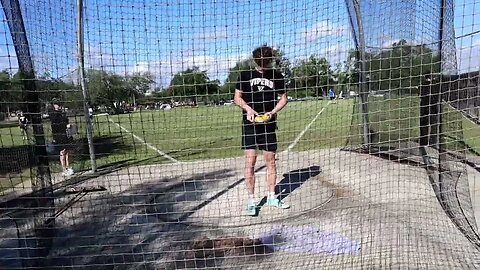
[242, 122, 277, 152]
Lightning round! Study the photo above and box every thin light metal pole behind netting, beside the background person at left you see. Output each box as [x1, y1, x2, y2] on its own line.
[77, 0, 97, 172]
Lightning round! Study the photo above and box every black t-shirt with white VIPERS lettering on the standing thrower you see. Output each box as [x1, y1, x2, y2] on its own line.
[236, 69, 285, 123]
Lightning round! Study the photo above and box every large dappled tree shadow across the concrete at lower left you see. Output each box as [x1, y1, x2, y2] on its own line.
[0, 170, 274, 269]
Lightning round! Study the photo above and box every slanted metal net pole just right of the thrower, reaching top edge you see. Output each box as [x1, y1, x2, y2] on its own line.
[347, 0, 371, 149]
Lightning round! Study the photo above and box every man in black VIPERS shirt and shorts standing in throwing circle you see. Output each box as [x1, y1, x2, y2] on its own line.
[234, 46, 289, 215]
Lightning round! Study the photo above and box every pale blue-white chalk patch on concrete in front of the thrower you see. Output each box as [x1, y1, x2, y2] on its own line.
[259, 225, 360, 255]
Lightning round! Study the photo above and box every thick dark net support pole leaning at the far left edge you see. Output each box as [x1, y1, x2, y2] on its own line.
[0, 0, 55, 269]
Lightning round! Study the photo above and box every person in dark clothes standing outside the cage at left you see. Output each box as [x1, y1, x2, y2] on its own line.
[49, 99, 73, 176]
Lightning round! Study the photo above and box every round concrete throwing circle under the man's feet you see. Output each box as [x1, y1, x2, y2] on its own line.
[185, 171, 334, 227]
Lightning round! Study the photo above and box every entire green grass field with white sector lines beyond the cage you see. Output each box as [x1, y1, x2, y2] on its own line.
[0, 97, 480, 190]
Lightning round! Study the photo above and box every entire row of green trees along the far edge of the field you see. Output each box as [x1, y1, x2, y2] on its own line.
[0, 40, 440, 117]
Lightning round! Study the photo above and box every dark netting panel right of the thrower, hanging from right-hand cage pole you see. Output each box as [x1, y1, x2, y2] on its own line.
[349, 1, 480, 252]
